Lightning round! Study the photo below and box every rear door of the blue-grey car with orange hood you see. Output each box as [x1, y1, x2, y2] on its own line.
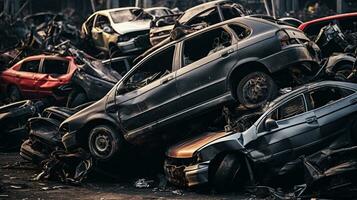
[306, 86, 354, 148]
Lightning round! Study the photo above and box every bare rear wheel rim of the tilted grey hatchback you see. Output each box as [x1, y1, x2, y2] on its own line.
[242, 75, 269, 104]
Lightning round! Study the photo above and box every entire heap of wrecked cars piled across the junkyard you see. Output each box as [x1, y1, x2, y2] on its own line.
[0, 0, 357, 198]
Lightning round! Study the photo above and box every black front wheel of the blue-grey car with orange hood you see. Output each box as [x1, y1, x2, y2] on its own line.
[212, 154, 243, 192]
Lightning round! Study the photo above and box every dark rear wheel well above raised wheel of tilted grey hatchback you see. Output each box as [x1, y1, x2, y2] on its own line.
[229, 61, 270, 99]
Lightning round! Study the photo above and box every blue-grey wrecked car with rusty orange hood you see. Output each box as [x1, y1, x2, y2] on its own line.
[164, 81, 357, 190]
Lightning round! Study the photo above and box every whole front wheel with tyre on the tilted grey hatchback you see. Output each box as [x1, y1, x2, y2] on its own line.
[88, 125, 124, 161]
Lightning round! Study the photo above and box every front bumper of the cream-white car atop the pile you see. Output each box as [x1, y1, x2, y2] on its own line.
[117, 34, 150, 54]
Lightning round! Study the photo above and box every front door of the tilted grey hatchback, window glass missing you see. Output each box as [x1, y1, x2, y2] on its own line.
[116, 46, 177, 137]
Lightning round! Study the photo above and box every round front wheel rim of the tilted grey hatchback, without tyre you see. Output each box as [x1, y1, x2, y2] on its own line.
[91, 130, 113, 158]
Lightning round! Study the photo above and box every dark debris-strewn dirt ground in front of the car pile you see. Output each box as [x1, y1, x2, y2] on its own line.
[0, 153, 254, 200]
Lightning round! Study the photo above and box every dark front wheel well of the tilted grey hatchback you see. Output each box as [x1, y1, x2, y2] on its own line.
[77, 119, 120, 150]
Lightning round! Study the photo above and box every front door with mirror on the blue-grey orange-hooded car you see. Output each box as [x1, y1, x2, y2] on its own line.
[247, 94, 320, 167]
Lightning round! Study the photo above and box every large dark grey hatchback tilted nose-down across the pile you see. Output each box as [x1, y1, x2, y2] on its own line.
[60, 17, 318, 160]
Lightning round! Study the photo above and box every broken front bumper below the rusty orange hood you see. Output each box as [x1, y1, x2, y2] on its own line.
[164, 161, 210, 187]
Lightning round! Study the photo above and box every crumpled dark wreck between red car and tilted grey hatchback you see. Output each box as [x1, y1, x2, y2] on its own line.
[67, 50, 133, 108]
